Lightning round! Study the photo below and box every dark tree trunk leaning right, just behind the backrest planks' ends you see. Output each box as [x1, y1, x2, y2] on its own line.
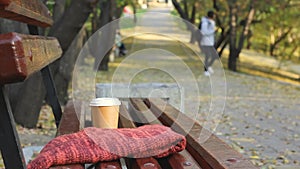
[49, 0, 96, 104]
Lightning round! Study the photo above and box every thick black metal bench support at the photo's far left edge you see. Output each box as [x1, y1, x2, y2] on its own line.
[0, 86, 26, 169]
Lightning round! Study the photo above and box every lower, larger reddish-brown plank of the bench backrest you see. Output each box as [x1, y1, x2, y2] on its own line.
[0, 32, 62, 84]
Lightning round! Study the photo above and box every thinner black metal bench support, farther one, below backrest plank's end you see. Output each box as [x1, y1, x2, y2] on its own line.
[41, 66, 62, 128]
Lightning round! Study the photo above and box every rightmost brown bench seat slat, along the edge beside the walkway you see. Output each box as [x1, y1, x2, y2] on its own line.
[146, 98, 257, 169]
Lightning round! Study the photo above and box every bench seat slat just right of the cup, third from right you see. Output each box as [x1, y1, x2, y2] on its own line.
[119, 105, 161, 169]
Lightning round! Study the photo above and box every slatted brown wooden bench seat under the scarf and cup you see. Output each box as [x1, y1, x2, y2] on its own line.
[52, 98, 257, 169]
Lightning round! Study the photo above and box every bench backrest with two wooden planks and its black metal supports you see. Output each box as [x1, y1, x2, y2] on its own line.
[0, 0, 62, 169]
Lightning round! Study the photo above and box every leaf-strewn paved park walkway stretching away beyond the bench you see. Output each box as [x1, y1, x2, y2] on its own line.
[116, 4, 300, 167]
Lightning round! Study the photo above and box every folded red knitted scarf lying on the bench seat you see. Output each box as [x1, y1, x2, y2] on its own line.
[27, 125, 186, 169]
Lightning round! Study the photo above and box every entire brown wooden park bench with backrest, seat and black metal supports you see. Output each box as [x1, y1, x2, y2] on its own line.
[0, 0, 256, 169]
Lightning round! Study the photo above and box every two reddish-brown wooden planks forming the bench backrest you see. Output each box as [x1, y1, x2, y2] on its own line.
[0, 0, 62, 84]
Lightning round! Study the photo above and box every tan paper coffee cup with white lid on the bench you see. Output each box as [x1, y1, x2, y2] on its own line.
[90, 98, 121, 128]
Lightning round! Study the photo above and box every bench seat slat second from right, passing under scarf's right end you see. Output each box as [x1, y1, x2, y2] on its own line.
[130, 99, 201, 169]
